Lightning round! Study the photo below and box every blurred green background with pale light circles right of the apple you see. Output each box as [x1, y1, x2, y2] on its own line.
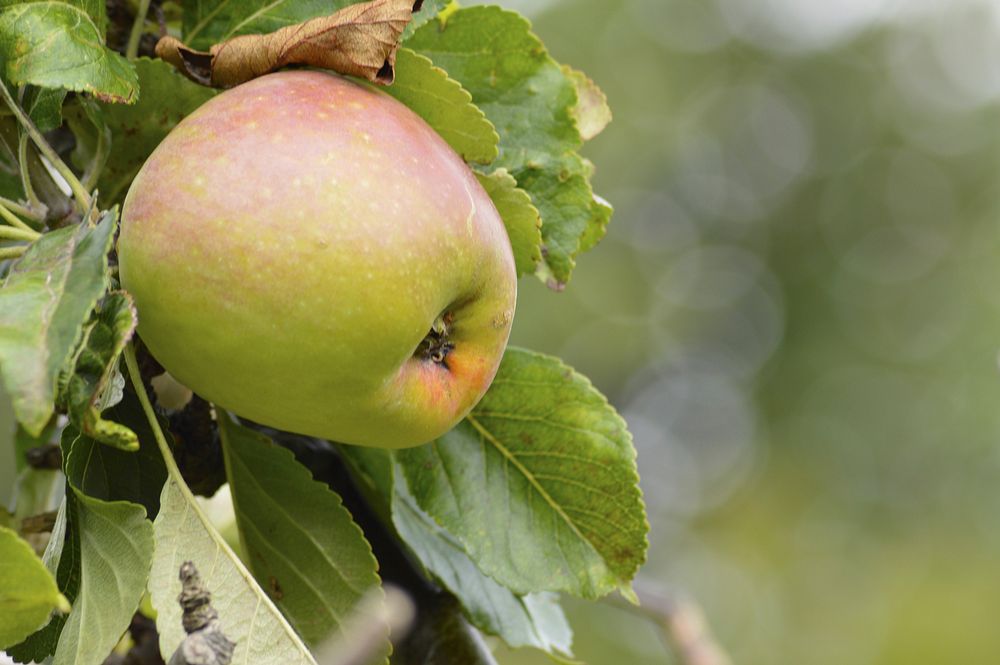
[482, 0, 1000, 665]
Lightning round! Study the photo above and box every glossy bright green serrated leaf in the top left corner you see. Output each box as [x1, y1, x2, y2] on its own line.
[0, 1, 139, 104]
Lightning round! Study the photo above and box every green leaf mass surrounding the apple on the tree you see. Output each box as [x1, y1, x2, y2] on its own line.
[0, 0, 648, 665]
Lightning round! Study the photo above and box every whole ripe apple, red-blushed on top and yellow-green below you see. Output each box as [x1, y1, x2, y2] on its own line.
[118, 71, 517, 448]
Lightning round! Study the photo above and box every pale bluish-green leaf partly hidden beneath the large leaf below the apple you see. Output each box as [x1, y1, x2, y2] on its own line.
[392, 464, 573, 655]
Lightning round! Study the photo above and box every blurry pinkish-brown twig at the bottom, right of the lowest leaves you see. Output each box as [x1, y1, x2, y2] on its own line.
[608, 589, 732, 665]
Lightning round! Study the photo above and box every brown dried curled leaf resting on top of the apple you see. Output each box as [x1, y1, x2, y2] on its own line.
[156, 0, 423, 88]
